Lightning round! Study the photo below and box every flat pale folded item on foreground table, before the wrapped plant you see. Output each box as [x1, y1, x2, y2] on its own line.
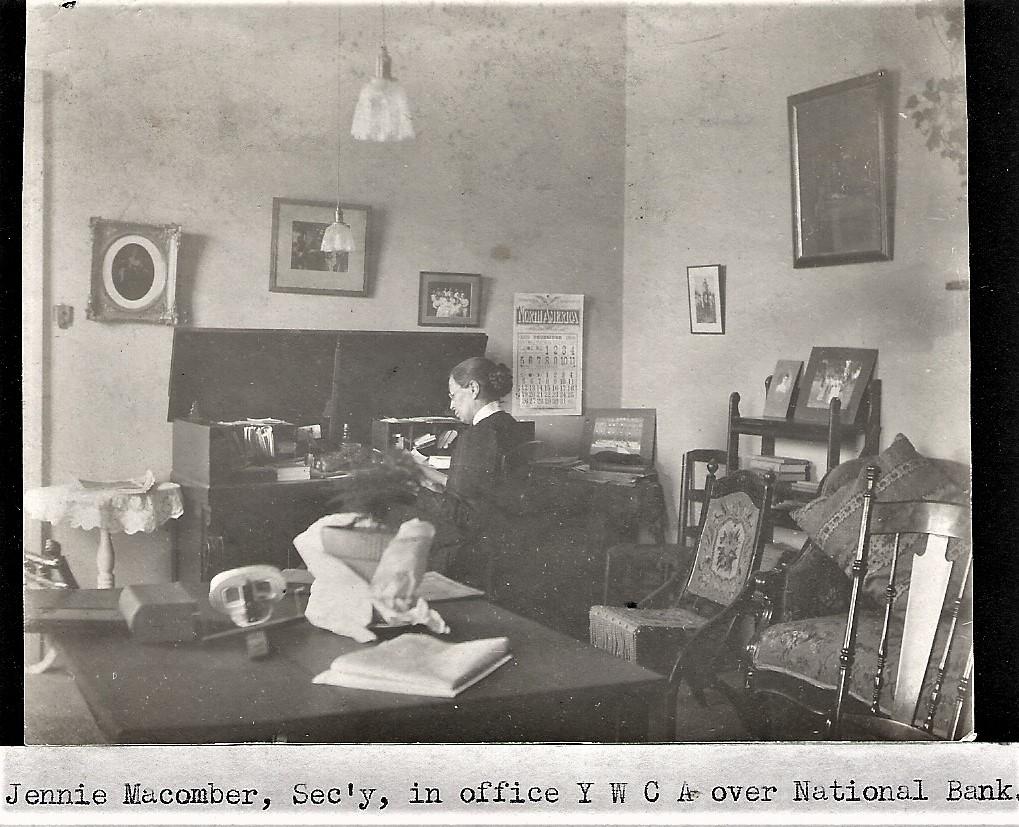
[313, 632, 513, 698]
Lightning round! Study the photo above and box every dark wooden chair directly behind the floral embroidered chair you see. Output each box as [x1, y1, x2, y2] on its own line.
[601, 448, 726, 605]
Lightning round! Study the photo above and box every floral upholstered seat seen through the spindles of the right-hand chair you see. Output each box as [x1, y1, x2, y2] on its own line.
[753, 612, 970, 736]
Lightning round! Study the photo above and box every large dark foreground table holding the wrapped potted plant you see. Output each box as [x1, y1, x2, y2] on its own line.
[29, 587, 672, 743]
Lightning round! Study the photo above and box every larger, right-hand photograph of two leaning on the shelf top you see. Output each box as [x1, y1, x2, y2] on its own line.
[793, 347, 877, 425]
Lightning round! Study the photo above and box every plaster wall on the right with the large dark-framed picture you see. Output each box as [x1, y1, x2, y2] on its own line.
[622, 3, 969, 533]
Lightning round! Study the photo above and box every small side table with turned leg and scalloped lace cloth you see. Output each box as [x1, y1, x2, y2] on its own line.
[24, 482, 184, 589]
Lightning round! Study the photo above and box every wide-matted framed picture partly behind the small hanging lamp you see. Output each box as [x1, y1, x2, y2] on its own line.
[269, 199, 371, 295]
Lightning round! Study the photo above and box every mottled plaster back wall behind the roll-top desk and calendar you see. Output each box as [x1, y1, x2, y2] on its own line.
[24, 3, 626, 587]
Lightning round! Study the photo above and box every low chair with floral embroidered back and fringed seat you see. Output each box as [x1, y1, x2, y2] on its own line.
[589, 472, 773, 674]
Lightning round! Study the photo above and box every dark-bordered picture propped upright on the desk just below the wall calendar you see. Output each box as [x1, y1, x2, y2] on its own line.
[580, 407, 656, 472]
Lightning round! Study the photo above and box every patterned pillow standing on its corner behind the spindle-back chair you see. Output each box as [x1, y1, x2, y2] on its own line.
[792, 434, 965, 603]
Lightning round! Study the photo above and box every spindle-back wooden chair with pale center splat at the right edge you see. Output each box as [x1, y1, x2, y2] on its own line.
[747, 465, 973, 740]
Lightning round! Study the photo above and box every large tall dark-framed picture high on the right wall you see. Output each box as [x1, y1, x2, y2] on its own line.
[788, 70, 894, 267]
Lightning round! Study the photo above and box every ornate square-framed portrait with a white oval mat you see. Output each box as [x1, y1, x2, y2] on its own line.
[85, 217, 180, 325]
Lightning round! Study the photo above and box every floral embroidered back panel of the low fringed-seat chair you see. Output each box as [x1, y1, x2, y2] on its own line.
[687, 491, 760, 606]
